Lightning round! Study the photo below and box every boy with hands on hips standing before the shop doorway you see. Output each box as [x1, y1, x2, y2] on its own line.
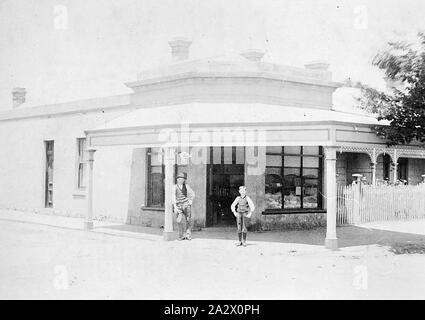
[231, 186, 255, 247]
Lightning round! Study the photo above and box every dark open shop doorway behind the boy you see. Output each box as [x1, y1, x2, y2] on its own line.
[206, 147, 245, 227]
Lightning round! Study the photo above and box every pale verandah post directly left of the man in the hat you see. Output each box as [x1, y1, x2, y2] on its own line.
[163, 147, 176, 241]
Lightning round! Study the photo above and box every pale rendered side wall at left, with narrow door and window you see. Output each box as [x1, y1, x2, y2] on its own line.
[0, 107, 131, 221]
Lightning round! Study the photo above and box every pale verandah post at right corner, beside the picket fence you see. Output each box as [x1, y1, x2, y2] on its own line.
[325, 147, 338, 250]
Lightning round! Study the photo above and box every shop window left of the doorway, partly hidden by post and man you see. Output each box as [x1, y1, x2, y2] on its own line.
[146, 148, 188, 208]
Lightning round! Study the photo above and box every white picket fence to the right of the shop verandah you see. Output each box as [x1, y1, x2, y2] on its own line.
[337, 183, 425, 225]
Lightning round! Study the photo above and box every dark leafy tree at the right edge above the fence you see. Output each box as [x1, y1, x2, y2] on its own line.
[358, 32, 425, 146]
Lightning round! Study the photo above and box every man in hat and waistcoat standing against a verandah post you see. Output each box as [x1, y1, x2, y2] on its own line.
[171, 172, 195, 240]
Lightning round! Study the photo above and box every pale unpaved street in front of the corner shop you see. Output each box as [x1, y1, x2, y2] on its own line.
[0, 220, 425, 299]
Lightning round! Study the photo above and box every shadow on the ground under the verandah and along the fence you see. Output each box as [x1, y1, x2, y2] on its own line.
[96, 225, 425, 253]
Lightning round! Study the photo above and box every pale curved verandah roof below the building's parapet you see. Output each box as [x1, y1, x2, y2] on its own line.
[86, 102, 386, 133]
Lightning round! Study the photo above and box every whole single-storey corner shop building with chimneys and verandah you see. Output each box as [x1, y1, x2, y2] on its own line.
[0, 39, 425, 248]
